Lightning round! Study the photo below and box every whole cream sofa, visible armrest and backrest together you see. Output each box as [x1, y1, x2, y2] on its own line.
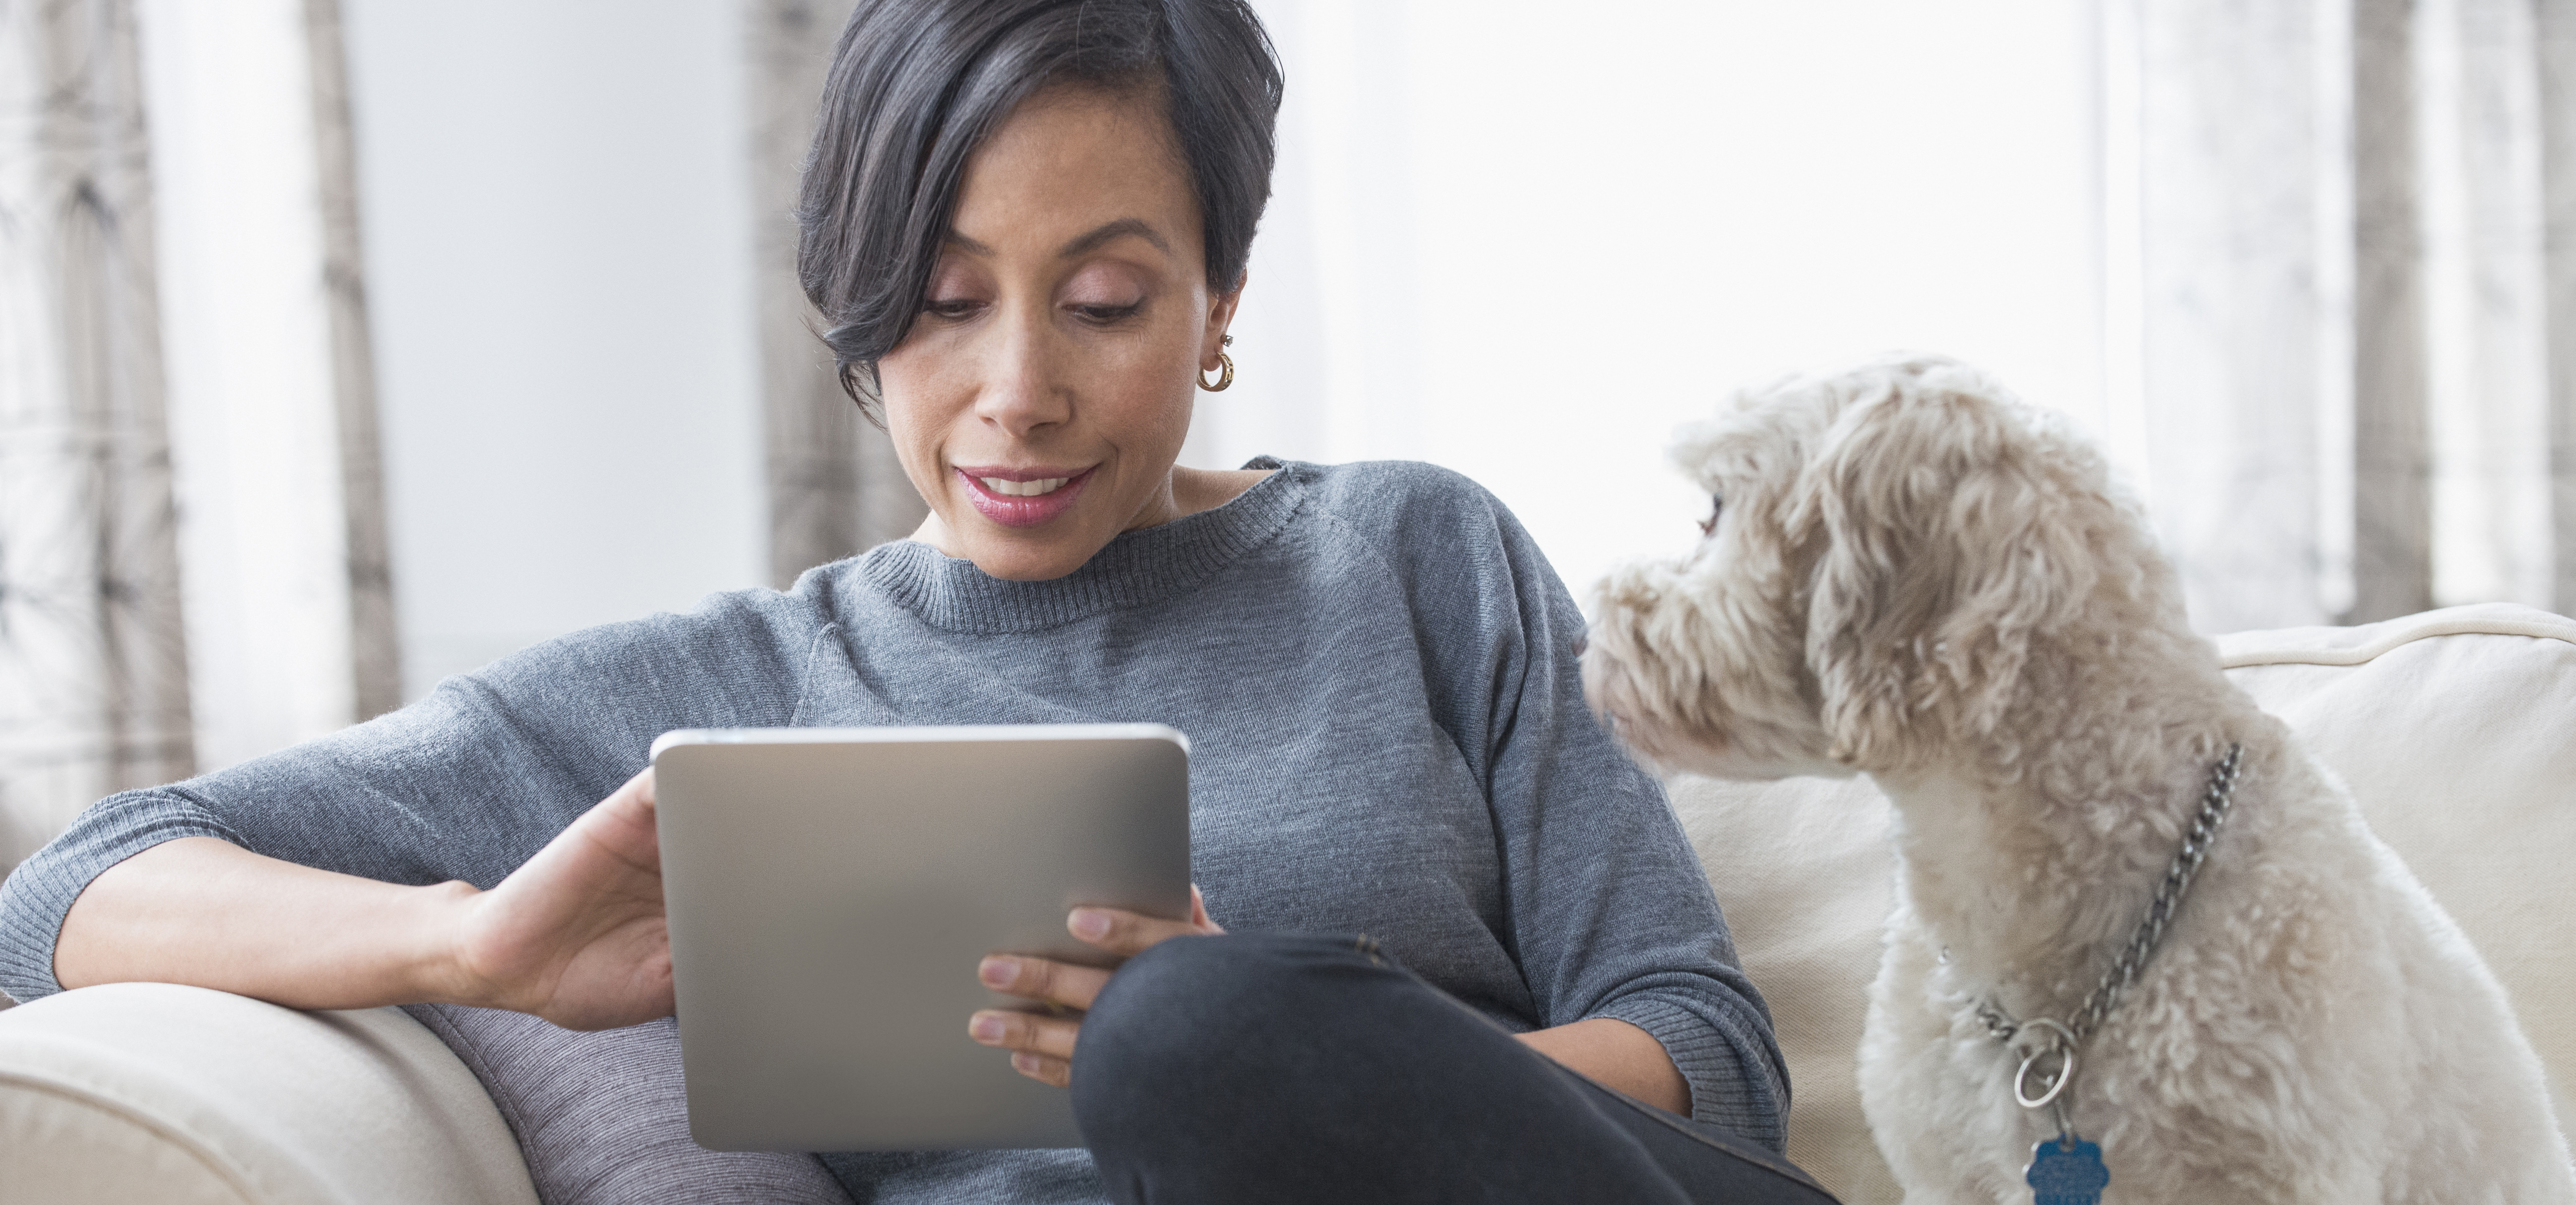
[0, 605, 2576, 1205]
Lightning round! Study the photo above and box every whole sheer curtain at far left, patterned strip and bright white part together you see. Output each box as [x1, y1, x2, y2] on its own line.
[0, 0, 402, 865]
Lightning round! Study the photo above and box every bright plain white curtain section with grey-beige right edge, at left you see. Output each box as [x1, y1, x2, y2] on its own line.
[137, 0, 402, 770]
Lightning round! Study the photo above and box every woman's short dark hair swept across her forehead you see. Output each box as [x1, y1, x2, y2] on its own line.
[796, 0, 1283, 417]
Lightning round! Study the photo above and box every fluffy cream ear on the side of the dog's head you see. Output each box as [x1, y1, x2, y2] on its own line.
[1788, 365, 2107, 770]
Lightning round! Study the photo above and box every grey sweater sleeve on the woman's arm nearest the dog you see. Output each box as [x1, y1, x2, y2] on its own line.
[1414, 471, 1788, 1151]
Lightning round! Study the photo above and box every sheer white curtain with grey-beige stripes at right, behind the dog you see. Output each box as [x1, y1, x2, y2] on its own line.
[2104, 0, 2576, 631]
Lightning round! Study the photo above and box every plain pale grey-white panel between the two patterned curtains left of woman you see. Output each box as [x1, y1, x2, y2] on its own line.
[342, 0, 765, 698]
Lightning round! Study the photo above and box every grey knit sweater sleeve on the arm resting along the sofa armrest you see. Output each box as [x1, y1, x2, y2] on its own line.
[0, 590, 819, 1001]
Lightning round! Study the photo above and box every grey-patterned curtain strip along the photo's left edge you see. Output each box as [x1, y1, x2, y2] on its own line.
[0, 0, 193, 865]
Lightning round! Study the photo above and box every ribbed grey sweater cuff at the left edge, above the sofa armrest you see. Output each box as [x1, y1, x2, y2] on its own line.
[0, 790, 242, 1001]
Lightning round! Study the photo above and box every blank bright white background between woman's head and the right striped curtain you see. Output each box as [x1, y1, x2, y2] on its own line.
[1185, 0, 2102, 597]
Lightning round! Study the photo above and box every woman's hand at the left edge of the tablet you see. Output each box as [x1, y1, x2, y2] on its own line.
[448, 767, 672, 1030]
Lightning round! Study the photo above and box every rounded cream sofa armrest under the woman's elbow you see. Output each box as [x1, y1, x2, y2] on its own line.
[0, 984, 536, 1205]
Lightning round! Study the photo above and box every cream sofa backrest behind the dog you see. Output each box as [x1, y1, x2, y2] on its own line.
[1669, 605, 2576, 1205]
